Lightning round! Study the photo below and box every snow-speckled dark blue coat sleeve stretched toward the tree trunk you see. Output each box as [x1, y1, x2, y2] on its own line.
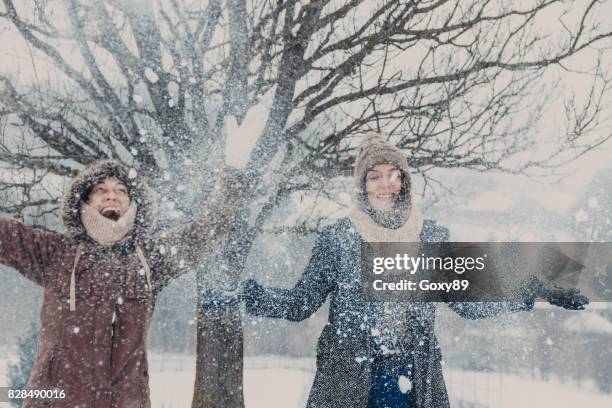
[244, 230, 335, 322]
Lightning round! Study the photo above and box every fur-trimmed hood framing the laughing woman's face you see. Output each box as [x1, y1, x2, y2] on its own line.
[61, 160, 155, 241]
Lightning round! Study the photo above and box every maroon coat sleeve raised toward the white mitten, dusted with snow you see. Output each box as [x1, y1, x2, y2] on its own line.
[151, 167, 244, 288]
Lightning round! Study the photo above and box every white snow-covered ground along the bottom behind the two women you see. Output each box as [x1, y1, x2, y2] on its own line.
[0, 353, 612, 408]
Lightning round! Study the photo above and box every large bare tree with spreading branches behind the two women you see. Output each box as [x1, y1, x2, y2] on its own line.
[0, 0, 612, 408]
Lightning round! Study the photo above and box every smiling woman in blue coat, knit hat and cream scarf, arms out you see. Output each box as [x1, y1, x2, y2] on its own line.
[208, 135, 584, 408]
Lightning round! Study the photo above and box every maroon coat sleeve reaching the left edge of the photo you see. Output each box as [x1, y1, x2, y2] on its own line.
[0, 219, 63, 286]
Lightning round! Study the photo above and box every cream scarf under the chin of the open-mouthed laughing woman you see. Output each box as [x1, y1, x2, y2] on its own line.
[81, 200, 137, 245]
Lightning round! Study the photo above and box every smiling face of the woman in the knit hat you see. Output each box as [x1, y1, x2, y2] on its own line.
[365, 164, 402, 211]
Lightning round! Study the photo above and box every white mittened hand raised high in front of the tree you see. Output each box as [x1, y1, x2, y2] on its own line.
[225, 88, 275, 169]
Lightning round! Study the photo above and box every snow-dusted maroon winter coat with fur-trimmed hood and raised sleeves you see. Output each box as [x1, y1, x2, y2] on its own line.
[0, 161, 242, 408]
